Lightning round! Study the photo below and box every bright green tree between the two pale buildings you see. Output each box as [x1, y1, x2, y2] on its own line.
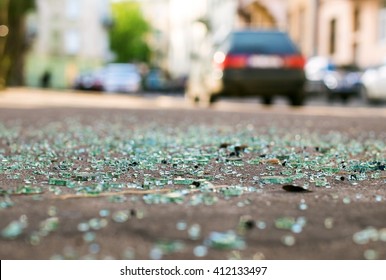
[110, 2, 150, 62]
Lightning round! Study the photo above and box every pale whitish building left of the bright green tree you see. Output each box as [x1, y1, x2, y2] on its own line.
[26, 0, 111, 88]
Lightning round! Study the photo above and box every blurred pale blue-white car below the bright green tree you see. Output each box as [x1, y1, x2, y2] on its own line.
[103, 63, 142, 93]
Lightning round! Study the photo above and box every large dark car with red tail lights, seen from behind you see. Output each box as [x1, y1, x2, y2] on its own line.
[186, 29, 305, 105]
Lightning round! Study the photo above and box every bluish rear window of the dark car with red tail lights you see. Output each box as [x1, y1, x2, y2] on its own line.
[229, 32, 299, 55]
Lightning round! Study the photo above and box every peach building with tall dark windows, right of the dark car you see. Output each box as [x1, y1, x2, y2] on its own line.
[288, 0, 386, 67]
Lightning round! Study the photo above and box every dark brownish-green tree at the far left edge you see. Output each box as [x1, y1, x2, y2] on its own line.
[0, 0, 35, 88]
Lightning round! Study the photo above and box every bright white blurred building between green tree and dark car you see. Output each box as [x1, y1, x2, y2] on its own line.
[139, 0, 237, 78]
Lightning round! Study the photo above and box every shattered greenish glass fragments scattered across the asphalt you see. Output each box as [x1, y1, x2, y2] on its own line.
[0, 119, 386, 259]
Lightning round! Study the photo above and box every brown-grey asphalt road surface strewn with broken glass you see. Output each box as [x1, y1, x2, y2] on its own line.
[0, 89, 386, 260]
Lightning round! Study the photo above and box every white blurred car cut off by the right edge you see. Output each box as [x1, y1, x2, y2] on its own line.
[361, 62, 386, 103]
